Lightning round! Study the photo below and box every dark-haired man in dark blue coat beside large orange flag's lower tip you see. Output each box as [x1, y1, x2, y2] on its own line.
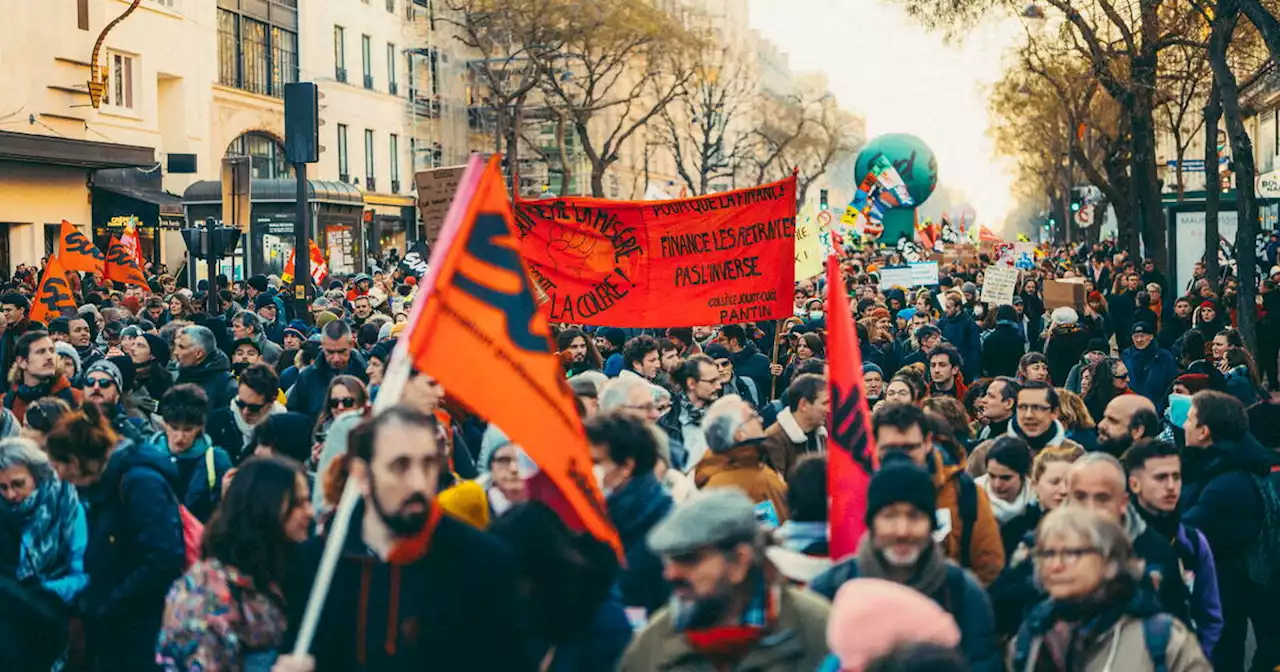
[585, 412, 675, 614]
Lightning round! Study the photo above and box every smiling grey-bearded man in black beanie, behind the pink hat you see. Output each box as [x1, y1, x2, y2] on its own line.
[809, 453, 1001, 671]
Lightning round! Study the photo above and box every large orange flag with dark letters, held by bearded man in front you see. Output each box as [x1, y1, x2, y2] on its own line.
[406, 156, 622, 556]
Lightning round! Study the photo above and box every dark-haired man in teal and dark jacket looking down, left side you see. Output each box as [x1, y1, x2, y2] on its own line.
[151, 383, 232, 522]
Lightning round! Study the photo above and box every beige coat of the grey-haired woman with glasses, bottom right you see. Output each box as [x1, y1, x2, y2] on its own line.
[1009, 616, 1213, 672]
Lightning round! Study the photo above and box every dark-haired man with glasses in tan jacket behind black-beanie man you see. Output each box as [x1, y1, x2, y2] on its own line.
[872, 402, 1005, 585]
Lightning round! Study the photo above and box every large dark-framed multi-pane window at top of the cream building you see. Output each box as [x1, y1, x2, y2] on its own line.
[218, 8, 298, 97]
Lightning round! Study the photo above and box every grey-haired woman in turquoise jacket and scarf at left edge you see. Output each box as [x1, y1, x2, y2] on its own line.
[0, 438, 88, 669]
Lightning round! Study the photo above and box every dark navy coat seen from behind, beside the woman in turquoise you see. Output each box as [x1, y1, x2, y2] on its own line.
[79, 439, 184, 669]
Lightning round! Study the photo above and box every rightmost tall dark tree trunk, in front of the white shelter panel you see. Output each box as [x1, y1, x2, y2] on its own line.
[1210, 0, 1258, 352]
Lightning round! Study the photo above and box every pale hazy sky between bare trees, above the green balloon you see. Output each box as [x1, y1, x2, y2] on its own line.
[751, 0, 1020, 228]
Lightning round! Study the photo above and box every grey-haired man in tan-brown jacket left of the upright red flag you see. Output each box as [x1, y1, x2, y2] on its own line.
[694, 394, 787, 525]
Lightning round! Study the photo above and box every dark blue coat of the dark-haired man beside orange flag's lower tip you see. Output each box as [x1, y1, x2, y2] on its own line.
[605, 474, 675, 613]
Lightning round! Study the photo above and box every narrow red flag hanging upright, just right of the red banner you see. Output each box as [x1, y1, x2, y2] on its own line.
[827, 256, 879, 559]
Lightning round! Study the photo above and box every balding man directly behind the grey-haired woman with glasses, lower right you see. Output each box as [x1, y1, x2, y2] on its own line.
[1066, 453, 1192, 623]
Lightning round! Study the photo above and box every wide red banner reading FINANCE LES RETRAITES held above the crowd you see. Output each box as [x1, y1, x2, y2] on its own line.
[516, 177, 796, 328]
